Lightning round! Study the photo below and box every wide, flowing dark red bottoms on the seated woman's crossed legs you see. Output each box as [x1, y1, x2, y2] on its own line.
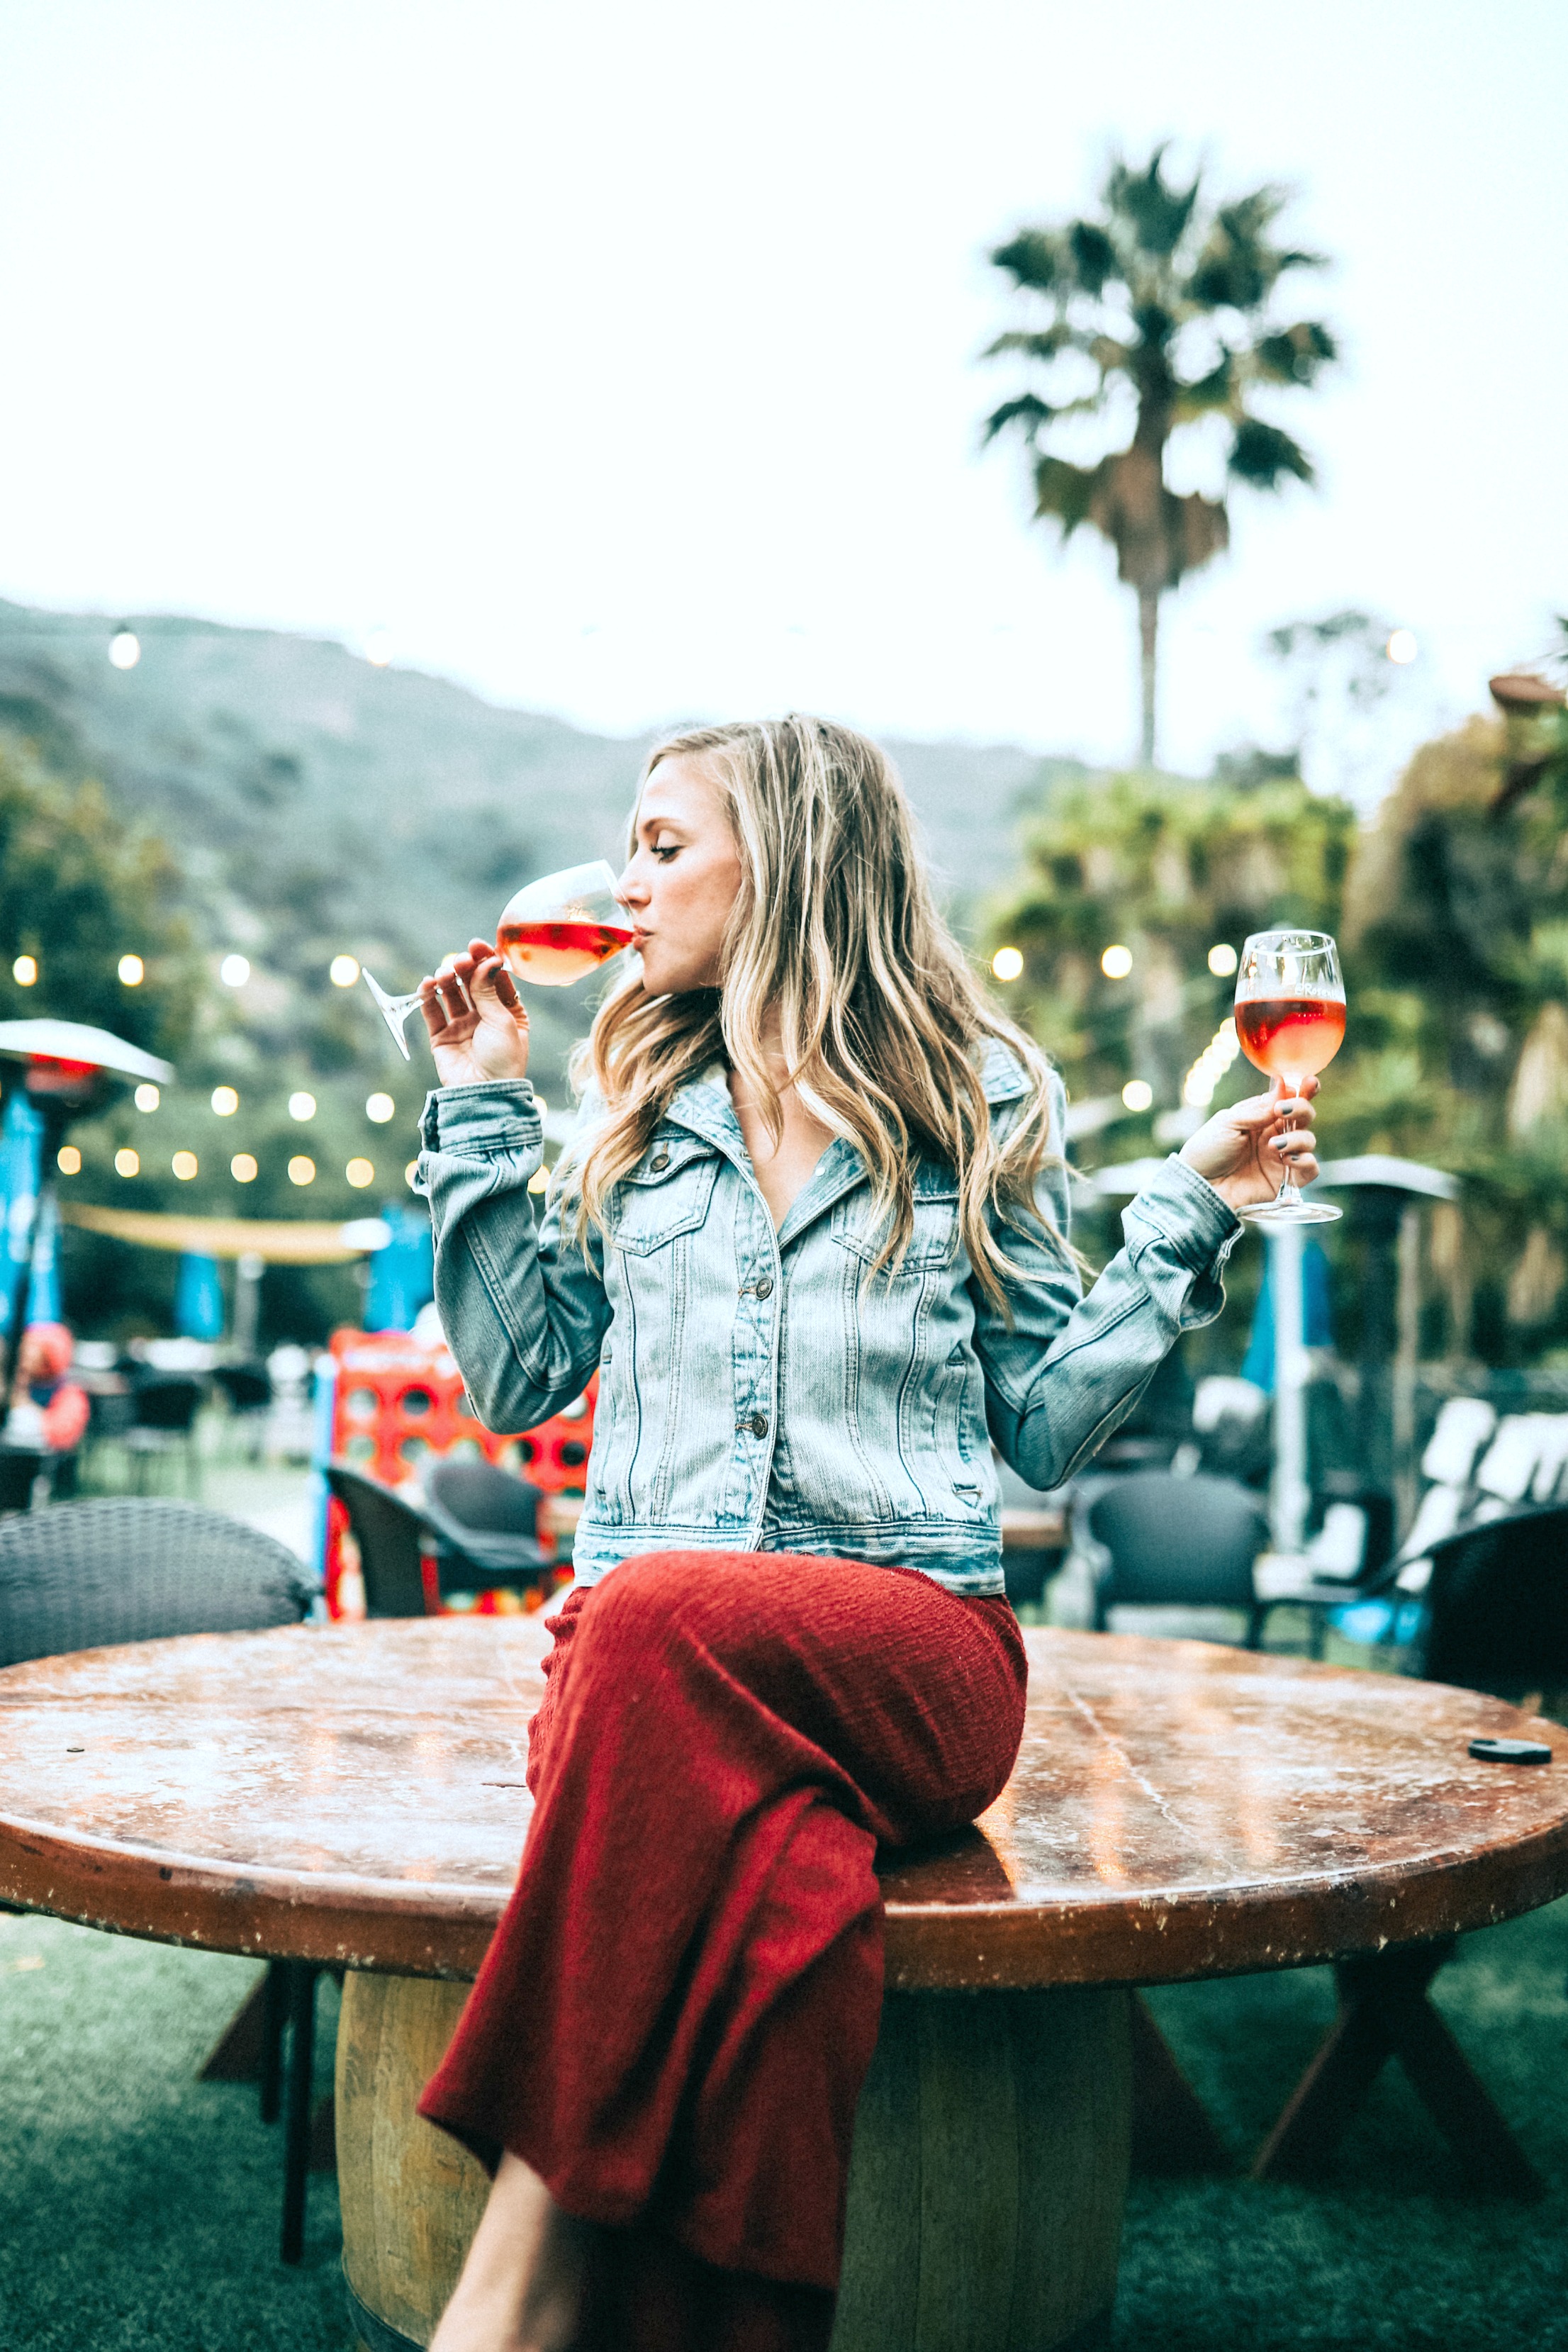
[421, 1552, 1027, 2352]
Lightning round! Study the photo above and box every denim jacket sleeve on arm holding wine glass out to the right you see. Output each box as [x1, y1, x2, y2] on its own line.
[971, 1080, 1241, 1489]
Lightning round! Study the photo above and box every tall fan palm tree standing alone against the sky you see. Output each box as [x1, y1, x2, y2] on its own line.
[985, 146, 1335, 767]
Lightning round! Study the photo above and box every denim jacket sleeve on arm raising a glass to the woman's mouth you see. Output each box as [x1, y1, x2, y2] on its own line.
[416, 1080, 609, 1430]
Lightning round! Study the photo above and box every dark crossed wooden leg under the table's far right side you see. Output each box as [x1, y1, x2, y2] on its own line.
[1253, 1936, 1545, 2197]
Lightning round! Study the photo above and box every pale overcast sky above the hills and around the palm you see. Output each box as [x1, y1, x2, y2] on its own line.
[0, 0, 1568, 795]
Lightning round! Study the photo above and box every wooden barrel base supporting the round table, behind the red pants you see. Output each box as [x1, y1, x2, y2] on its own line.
[336, 1971, 1131, 2352]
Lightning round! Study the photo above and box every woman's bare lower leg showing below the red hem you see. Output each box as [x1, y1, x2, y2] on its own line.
[430, 2154, 590, 2352]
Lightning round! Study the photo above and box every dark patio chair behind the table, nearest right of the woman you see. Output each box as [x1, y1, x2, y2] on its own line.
[1084, 1470, 1267, 1649]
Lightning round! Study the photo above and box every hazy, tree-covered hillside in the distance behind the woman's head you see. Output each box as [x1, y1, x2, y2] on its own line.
[0, 602, 1067, 1091]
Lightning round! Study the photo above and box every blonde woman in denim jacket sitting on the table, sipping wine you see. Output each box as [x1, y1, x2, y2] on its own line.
[418, 717, 1316, 2352]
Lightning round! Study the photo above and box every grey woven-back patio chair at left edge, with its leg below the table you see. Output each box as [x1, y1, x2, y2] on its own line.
[0, 1496, 320, 2263]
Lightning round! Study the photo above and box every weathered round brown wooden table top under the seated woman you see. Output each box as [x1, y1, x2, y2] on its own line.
[0, 1618, 1568, 1988]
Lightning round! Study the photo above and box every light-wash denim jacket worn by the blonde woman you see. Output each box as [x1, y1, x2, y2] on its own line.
[416, 1047, 1241, 1592]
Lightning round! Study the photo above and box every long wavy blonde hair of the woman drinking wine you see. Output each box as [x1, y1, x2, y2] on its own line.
[562, 712, 1065, 1308]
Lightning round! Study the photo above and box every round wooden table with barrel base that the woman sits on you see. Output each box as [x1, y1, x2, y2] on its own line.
[0, 1618, 1568, 2352]
